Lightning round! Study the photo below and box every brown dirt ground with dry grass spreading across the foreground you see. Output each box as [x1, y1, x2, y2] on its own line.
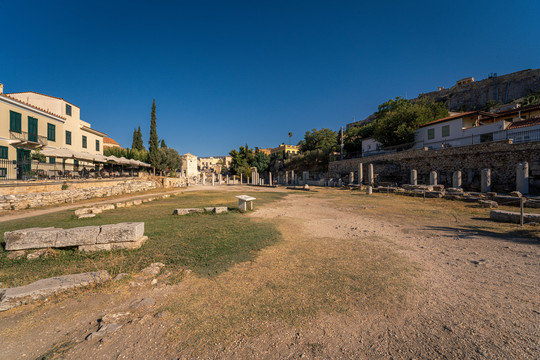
[0, 191, 540, 359]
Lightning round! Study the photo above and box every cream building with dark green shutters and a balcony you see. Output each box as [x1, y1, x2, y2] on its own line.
[0, 84, 106, 180]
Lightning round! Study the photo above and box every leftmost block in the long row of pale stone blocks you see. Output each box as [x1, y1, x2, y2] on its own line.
[4, 228, 62, 250]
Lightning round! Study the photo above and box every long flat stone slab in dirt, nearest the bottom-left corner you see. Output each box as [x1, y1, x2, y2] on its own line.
[0, 270, 111, 311]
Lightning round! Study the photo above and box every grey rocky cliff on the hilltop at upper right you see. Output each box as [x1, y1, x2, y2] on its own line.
[418, 69, 540, 111]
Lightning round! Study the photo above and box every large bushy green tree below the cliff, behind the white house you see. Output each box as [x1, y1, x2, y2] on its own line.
[373, 97, 448, 146]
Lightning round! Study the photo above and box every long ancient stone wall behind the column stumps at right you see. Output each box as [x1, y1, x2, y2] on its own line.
[328, 141, 540, 194]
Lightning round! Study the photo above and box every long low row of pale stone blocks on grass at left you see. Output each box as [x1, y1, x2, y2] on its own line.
[4, 222, 148, 251]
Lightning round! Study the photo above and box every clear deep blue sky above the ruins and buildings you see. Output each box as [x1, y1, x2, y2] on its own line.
[0, 0, 540, 156]
